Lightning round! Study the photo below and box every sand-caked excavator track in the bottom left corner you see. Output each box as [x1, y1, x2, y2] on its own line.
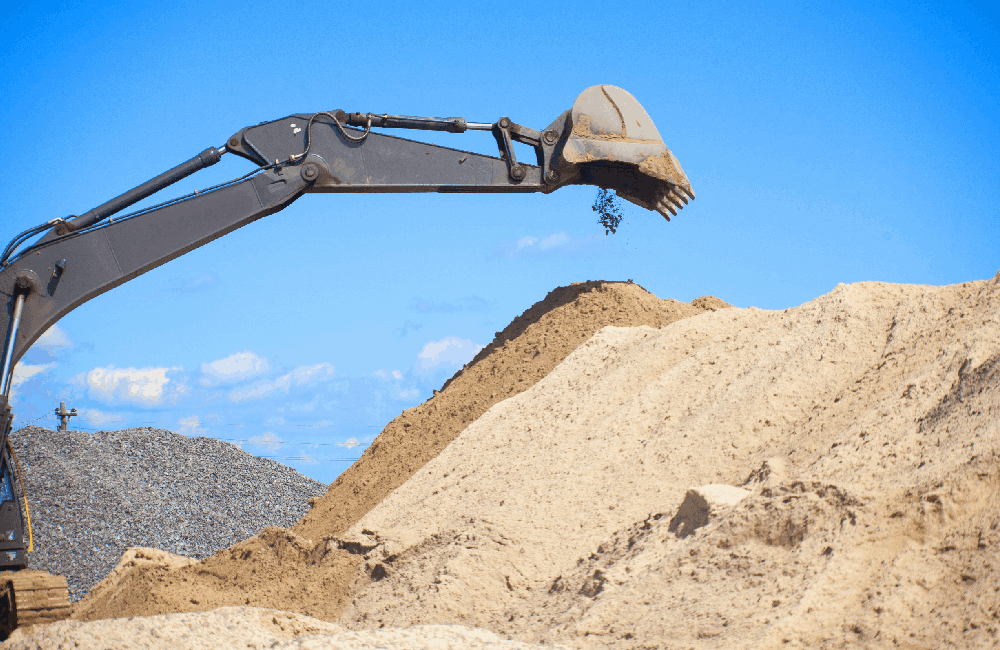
[0, 570, 70, 640]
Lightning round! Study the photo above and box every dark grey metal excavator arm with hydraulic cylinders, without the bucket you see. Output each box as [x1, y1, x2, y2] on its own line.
[0, 114, 570, 380]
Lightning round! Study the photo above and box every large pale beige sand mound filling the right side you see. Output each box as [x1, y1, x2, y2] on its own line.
[342, 275, 1000, 648]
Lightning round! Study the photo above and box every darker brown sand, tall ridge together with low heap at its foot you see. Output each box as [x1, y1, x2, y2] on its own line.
[74, 282, 728, 620]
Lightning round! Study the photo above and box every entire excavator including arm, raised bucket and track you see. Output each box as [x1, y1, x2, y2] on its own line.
[0, 85, 694, 638]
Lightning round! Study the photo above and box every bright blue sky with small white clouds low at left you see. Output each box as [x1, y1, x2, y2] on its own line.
[0, 1, 1000, 481]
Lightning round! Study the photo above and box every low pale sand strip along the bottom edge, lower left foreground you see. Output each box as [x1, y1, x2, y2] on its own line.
[2, 607, 568, 650]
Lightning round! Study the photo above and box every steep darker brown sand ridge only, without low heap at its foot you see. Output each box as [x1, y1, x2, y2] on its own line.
[293, 282, 730, 539]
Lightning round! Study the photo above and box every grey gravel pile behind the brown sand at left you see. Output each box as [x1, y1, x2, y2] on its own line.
[11, 427, 327, 601]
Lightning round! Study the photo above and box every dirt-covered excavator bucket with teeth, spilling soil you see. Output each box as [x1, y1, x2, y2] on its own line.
[562, 85, 694, 221]
